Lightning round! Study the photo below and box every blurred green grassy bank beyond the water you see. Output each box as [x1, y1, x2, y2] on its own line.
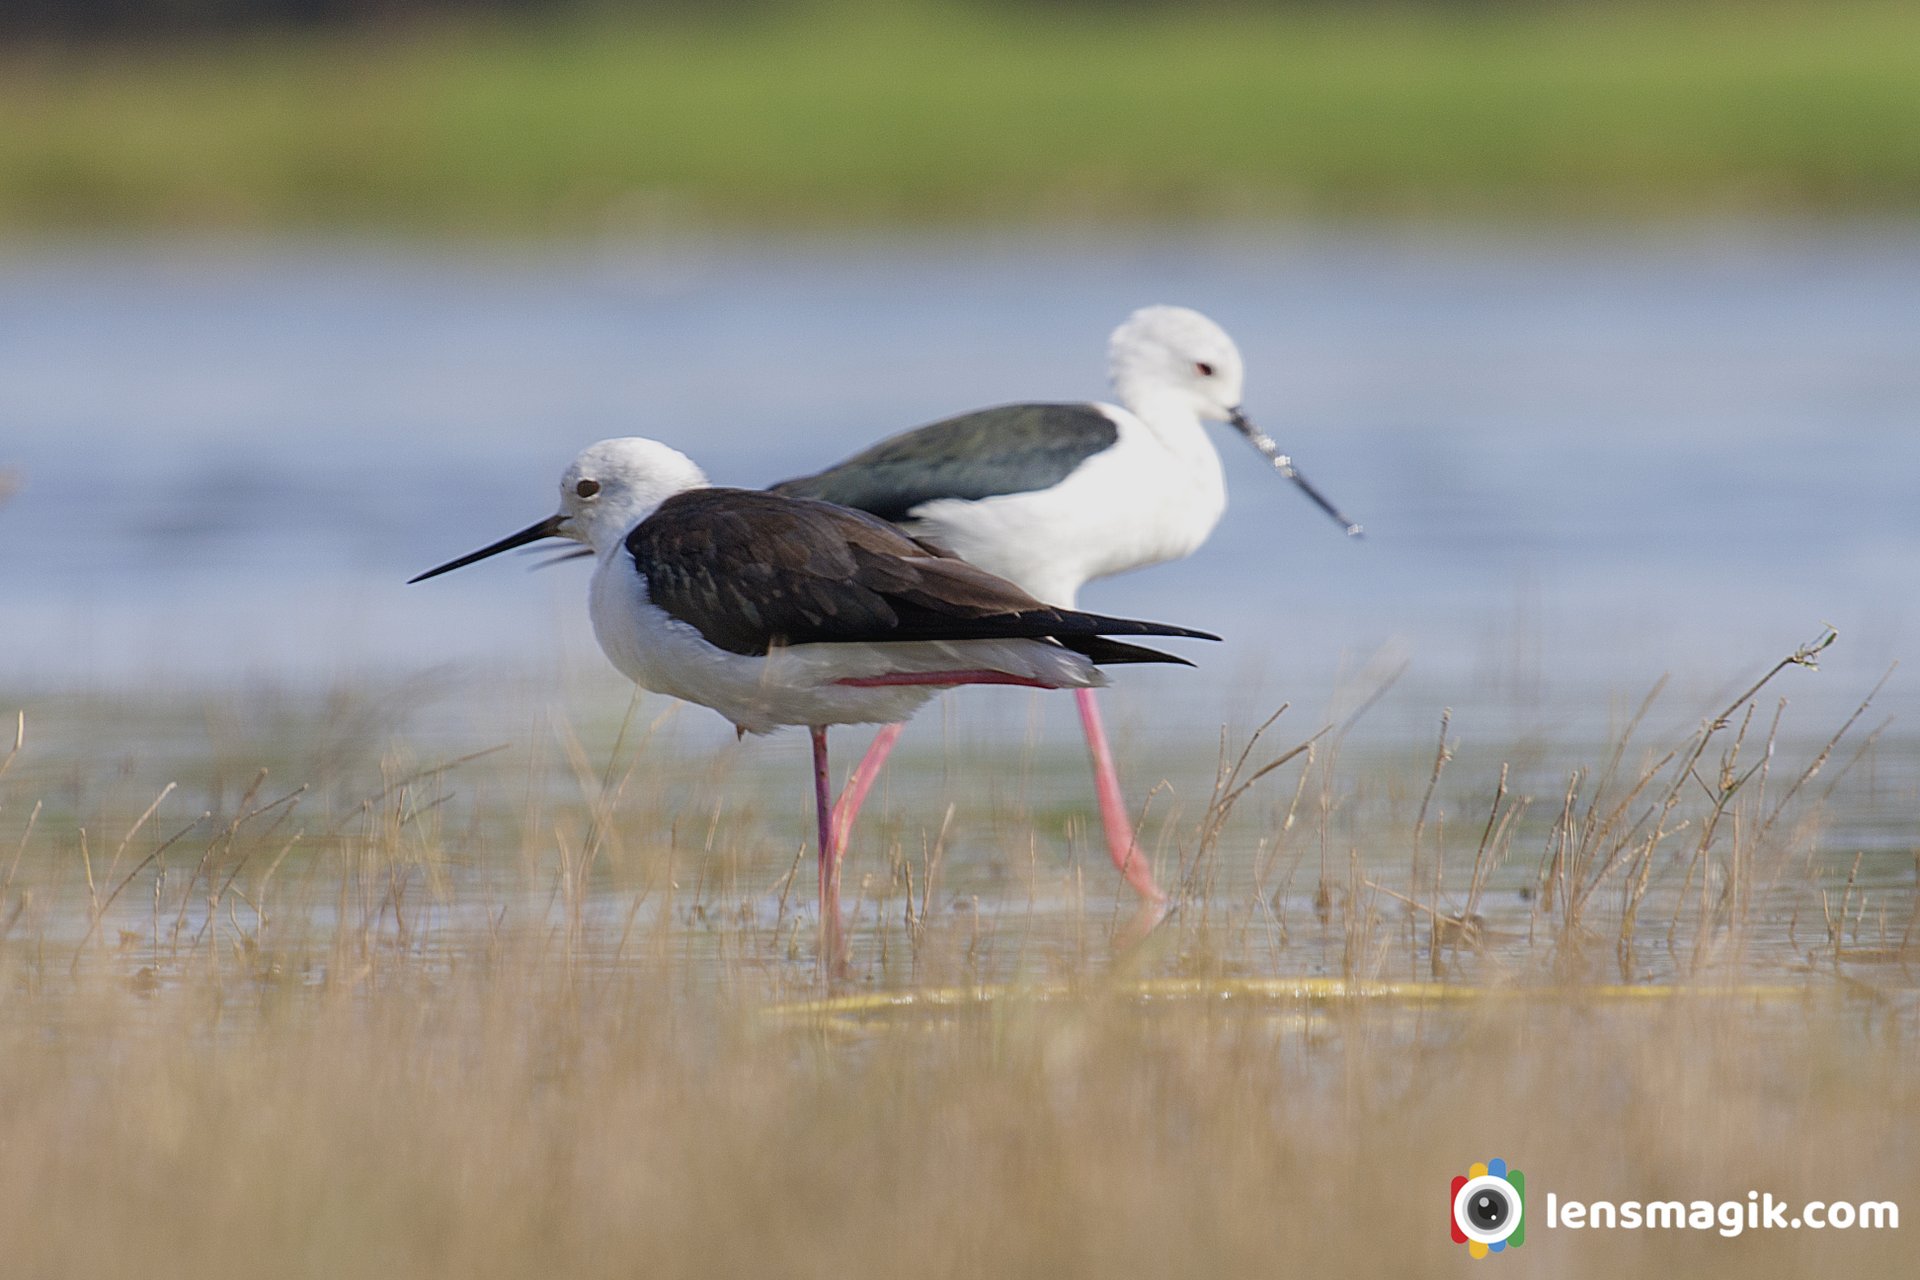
[0, 0, 1920, 232]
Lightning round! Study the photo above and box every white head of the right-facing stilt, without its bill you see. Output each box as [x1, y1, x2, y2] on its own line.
[1106, 307, 1246, 422]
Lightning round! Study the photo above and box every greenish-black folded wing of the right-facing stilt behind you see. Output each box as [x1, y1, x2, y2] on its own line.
[770, 405, 1119, 520]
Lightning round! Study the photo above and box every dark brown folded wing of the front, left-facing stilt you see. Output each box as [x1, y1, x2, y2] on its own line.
[626, 489, 1217, 662]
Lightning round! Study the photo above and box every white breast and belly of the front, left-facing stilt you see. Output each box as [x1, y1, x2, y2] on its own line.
[589, 545, 1106, 733]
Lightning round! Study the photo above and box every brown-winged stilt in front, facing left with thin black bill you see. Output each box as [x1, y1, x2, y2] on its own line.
[413, 439, 1217, 969]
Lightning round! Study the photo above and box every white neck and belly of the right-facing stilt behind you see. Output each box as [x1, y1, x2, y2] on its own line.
[906, 405, 1227, 608]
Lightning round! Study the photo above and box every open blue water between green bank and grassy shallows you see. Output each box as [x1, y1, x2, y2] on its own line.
[0, 226, 1920, 740]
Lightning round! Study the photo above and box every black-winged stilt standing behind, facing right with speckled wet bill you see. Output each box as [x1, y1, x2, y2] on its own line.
[772, 307, 1361, 904]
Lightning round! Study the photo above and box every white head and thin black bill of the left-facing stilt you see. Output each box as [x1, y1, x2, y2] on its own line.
[413, 436, 707, 581]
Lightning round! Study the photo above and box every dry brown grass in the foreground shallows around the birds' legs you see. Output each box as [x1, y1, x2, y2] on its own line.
[0, 643, 1920, 1276]
